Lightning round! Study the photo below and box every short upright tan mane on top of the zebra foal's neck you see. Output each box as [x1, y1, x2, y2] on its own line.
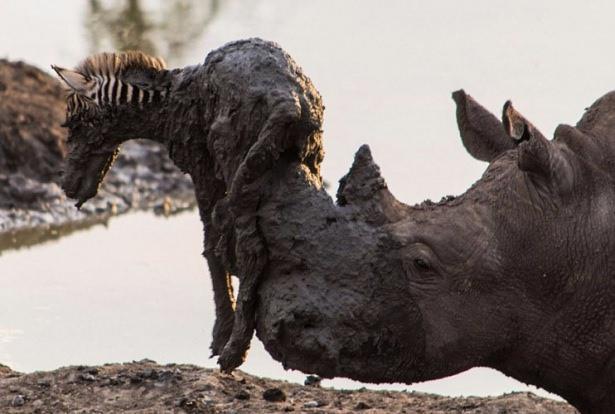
[76, 51, 166, 77]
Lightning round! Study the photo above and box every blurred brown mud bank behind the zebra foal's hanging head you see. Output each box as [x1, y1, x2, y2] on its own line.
[0, 59, 195, 251]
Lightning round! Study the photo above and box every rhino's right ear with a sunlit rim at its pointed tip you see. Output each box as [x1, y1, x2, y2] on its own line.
[502, 101, 573, 191]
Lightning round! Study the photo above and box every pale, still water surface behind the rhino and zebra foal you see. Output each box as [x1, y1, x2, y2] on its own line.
[0, 0, 615, 402]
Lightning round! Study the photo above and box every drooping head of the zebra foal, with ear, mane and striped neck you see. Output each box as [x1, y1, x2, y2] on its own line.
[52, 52, 170, 207]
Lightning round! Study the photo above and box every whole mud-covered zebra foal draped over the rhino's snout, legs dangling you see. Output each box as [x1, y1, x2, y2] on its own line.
[53, 39, 323, 370]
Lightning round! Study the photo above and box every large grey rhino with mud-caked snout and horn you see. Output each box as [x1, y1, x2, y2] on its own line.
[257, 91, 615, 412]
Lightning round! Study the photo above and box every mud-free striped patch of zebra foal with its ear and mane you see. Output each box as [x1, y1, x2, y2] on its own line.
[52, 52, 168, 115]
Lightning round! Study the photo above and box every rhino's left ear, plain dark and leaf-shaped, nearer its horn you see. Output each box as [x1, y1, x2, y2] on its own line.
[453, 89, 515, 162]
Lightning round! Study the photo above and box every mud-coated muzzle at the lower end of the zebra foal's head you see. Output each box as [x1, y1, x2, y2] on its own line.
[62, 152, 116, 208]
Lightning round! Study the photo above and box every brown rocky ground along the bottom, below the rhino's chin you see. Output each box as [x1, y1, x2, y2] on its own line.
[0, 360, 577, 414]
